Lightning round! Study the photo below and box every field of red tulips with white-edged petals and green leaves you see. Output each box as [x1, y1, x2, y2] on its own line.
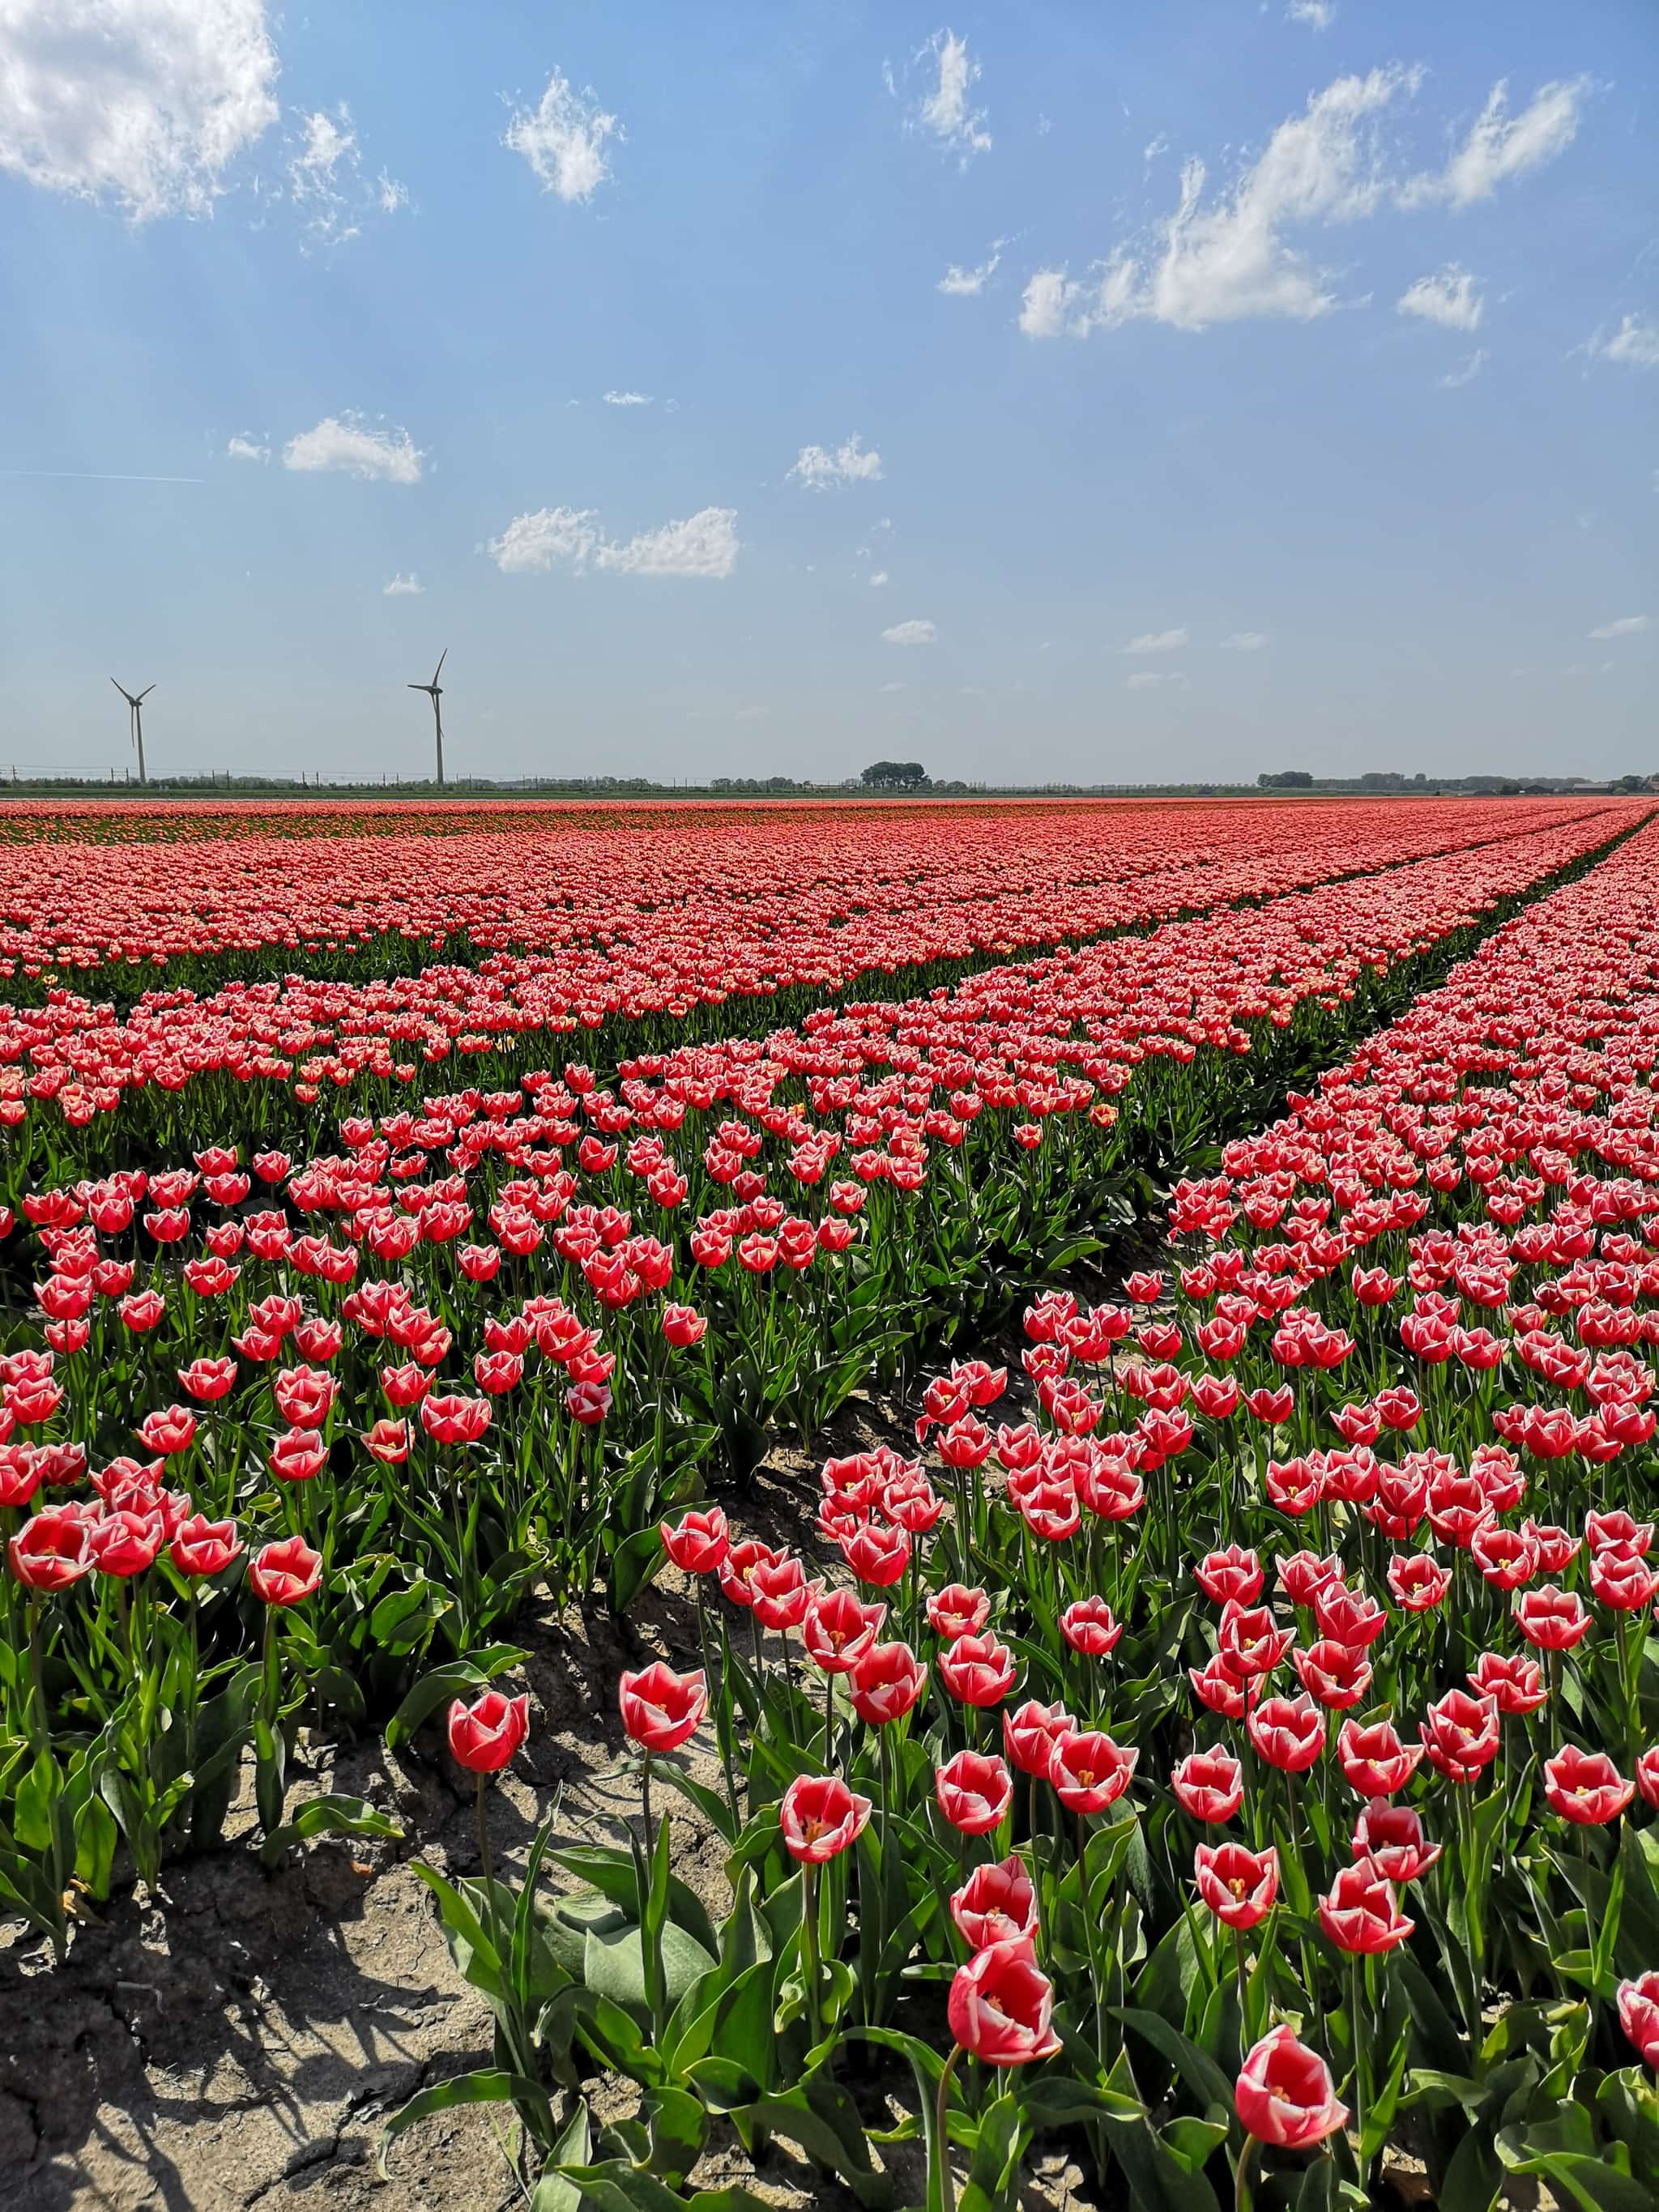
[0, 794, 1659, 2212]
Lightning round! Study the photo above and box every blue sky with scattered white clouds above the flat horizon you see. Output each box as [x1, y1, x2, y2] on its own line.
[0, 0, 1659, 781]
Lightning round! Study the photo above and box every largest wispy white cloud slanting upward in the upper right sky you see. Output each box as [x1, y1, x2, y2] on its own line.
[1020, 66, 1420, 339]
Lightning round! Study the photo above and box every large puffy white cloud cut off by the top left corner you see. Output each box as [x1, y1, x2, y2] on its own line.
[0, 0, 279, 224]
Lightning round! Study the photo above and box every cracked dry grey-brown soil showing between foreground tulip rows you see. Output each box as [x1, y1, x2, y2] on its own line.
[0, 1407, 1119, 2212]
